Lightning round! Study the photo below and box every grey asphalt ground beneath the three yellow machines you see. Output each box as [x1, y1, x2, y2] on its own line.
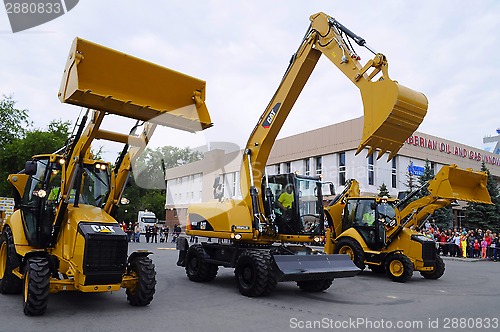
[0, 243, 500, 332]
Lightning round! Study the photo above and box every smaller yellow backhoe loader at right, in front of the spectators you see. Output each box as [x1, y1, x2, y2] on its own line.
[325, 165, 491, 282]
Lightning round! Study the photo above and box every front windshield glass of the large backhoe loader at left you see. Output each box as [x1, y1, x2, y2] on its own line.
[80, 164, 109, 207]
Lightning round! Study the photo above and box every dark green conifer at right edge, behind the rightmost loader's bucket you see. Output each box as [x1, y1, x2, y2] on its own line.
[465, 162, 500, 231]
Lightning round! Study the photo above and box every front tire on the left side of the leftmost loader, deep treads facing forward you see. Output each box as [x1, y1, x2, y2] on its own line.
[23, 257, 51, 316]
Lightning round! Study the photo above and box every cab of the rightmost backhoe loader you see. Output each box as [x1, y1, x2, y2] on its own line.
[342, 198, 396, 250]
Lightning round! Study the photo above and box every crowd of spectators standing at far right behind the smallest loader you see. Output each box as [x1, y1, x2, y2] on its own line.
[421, 222, 500, 262]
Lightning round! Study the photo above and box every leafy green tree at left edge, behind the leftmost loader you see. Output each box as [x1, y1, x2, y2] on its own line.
[0, 120, 70, 196]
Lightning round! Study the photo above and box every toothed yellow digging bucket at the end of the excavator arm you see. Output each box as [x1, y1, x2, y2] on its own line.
[356, 79, 428, 160]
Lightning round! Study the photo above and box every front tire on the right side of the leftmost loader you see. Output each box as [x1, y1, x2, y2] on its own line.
[126, 256, 156, 307]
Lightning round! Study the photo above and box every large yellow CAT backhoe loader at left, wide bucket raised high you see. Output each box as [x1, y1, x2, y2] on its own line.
[0, 38, 212, 315]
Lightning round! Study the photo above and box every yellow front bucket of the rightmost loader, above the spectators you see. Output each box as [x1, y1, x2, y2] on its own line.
[427, 165, 492, 204]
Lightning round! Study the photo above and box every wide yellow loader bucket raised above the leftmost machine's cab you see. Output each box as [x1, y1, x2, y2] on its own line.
[59, 38, 212, 132]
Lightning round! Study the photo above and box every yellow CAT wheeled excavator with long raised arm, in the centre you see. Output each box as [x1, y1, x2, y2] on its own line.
[177, 13, 427, 297]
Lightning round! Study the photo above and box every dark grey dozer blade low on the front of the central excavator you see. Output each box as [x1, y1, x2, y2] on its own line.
[273, 255, 361, 281]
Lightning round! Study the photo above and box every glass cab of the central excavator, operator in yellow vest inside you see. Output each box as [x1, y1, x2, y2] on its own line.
[261, 173, 324, 235]
